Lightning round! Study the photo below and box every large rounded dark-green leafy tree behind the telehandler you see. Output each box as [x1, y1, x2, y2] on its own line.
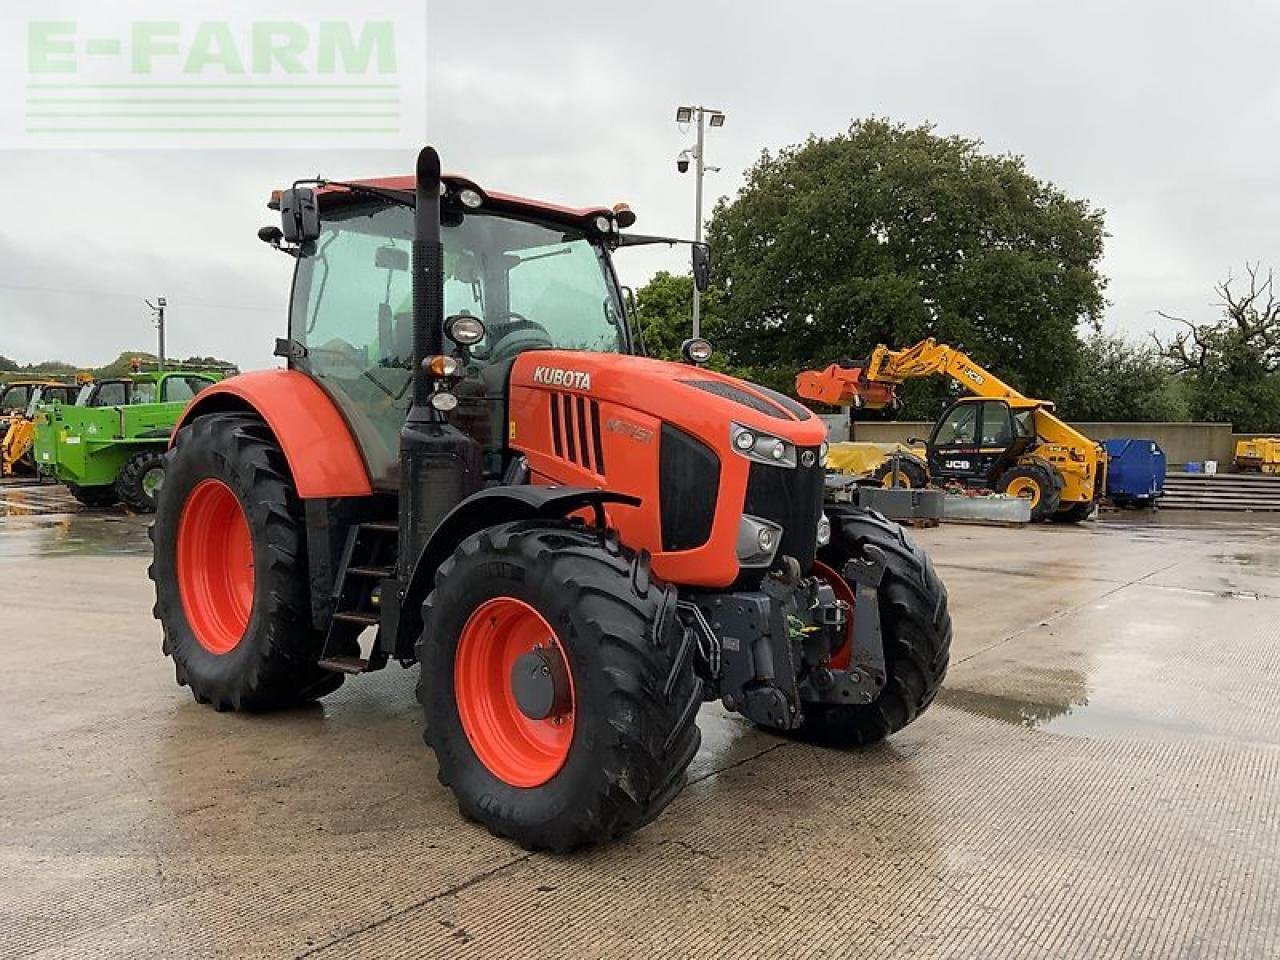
[708, 119, 1105, 415]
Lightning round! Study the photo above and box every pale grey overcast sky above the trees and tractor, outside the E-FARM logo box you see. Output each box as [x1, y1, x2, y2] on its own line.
[0, 0, 1280, 367]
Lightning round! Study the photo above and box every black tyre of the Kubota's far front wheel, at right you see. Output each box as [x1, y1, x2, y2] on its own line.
[795, 504, 951, 746]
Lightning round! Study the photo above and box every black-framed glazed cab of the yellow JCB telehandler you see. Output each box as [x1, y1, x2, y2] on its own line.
[927, 397, 1036, 486]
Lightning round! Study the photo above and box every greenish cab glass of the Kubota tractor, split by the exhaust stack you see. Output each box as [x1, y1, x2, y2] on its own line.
[289, 202, 630, 485]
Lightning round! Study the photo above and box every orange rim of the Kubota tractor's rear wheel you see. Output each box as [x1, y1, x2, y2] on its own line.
[178, 479, 253, 655]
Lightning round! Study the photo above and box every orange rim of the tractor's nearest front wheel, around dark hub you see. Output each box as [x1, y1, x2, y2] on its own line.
[453, 596, 577, 787]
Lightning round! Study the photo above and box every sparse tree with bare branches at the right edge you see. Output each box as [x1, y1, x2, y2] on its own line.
[1153, 264, 1280, 433]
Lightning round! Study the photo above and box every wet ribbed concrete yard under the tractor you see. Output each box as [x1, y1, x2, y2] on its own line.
[0, 492, 1280, 957]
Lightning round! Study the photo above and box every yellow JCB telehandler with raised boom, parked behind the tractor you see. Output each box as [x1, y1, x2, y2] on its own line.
[796, 337, 1107, 522]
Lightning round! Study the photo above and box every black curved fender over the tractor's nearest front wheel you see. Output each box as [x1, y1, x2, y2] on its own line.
[383, 485, 640, 659]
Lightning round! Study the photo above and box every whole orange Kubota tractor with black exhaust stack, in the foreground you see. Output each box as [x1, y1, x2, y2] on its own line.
[151, 147, 951, 850]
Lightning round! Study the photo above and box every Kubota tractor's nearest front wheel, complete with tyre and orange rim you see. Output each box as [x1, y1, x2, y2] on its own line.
[417, 521, 703, 852]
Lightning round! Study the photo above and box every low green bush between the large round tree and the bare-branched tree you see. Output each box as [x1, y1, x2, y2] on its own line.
[1053, 333, 1188, 422]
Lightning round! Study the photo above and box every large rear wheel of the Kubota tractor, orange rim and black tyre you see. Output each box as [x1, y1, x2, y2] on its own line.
[147, 413, 342, 710]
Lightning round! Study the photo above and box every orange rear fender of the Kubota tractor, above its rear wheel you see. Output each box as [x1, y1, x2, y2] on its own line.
[170, 370, 374, 499]
